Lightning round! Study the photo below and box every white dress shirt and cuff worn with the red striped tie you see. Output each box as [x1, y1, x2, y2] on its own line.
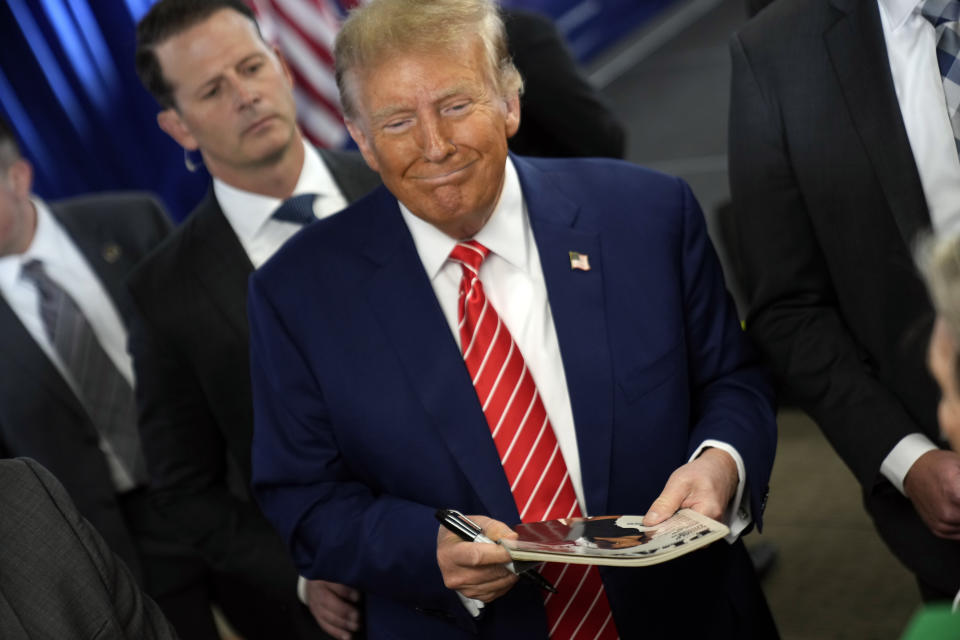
[400, 158, 750, 542]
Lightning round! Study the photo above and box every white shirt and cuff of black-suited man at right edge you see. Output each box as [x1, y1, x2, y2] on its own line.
[878, 0, 960, 493]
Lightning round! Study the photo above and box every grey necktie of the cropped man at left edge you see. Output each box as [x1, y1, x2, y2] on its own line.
[23, 260, 147, 485]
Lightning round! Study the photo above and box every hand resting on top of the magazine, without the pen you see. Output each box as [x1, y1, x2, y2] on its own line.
[643, 447, 739, 527]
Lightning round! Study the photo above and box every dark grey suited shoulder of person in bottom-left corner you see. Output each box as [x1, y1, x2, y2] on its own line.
[0, 459, 177, 640]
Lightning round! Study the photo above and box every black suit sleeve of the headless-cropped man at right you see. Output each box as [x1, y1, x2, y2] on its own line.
[729, 36, 920, 489]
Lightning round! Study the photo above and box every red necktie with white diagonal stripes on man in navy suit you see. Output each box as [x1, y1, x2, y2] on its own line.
[450, 240, 617, 640]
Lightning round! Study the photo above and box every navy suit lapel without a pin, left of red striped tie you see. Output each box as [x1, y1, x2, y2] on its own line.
[365, 189, 519, 522]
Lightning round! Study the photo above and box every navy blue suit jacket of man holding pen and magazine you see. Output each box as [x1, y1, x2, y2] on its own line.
[249, 157, 776, 639]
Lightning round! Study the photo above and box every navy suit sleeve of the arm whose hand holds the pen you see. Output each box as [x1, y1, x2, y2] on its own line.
[248, 273, 465, 618]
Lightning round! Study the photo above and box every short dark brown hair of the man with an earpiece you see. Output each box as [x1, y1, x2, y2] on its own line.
[134, 0, 263, 109]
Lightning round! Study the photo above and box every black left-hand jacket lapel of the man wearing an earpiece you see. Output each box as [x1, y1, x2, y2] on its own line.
[188, 189, 253, 344]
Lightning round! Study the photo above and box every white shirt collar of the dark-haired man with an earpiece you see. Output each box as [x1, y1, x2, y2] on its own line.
[213, 141, 340, 242]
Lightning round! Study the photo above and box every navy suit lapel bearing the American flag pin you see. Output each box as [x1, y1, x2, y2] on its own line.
[513, 157, 614, 514]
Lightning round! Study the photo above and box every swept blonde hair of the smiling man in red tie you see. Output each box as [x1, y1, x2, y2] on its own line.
[334, 0, 523, 120]
